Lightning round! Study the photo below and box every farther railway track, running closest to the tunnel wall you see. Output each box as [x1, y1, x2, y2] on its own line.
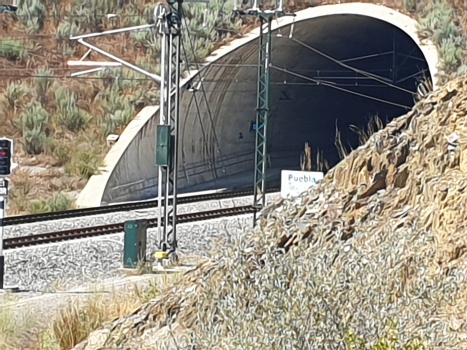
[3, 188, 279, 226]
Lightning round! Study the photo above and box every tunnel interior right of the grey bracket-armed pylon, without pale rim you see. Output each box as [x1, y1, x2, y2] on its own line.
[179, 14, 430, 193]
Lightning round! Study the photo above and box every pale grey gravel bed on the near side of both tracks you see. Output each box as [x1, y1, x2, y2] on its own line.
[5, 214, 252, 295]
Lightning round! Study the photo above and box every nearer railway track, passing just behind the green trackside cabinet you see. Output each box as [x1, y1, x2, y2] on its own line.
[3, 206, 253, 249]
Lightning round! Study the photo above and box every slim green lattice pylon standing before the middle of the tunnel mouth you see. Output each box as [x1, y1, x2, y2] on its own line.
[234, 0, 295, 226]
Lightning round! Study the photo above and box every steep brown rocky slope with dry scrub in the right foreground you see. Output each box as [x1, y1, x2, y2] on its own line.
[71, 77, 467, 350]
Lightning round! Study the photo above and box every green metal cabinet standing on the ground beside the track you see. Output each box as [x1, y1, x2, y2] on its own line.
[123, 220, 148, 269]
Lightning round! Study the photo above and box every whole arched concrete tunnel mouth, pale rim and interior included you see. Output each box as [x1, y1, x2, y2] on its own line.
[78, 3, 437, 206]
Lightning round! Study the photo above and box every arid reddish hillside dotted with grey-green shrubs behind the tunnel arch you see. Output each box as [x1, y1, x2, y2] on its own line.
[0, 0, 467, 215]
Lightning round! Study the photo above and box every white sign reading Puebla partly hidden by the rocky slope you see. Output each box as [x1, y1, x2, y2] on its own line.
[281, 170, 324, 198]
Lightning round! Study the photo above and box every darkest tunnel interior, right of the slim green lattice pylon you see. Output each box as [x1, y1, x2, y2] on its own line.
[269, 15, 429, 174]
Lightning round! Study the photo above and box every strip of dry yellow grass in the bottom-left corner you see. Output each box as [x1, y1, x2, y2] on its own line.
[0, 274, 180, 350]
